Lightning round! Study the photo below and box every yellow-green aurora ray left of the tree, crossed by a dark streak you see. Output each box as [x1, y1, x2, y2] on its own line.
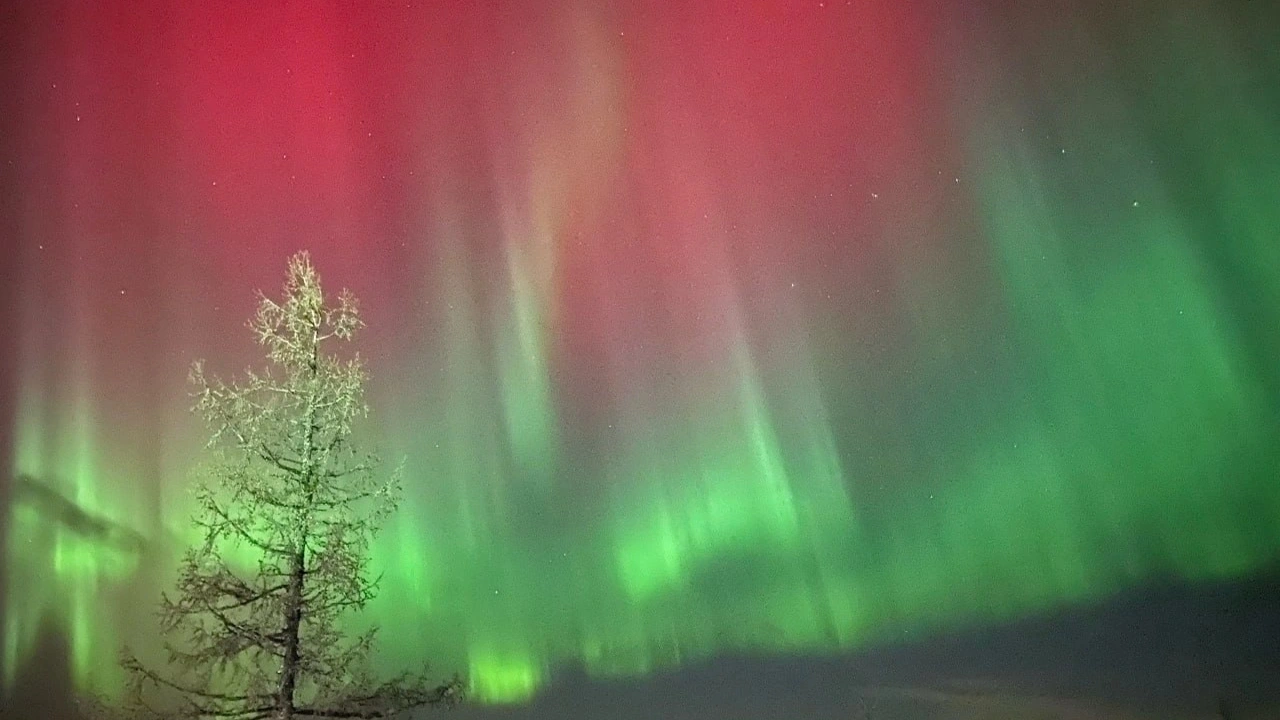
[3, 238, 142, 687]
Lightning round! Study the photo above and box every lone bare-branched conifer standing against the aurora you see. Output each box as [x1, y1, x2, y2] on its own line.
[124, 252, 462, 720]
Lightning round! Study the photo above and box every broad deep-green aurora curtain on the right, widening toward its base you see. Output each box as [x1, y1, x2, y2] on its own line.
[839, 0, 1280, 635]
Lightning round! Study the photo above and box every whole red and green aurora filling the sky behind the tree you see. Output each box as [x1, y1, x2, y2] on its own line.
[0, 0, 1280, 705]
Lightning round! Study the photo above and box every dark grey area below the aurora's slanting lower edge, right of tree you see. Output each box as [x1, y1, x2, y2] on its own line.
[457, 573, 1280, 720]
